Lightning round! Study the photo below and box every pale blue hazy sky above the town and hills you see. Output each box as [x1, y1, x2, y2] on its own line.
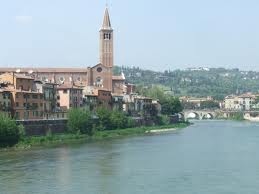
[0, 0, 259, 71]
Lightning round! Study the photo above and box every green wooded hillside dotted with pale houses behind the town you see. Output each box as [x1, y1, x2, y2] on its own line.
[114, 67, 259, 99]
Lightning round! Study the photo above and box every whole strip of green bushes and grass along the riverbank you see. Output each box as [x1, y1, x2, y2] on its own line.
[0, 108, 189, 149]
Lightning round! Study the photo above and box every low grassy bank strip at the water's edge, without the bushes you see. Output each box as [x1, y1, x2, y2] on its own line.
[10, 122, 190, 149]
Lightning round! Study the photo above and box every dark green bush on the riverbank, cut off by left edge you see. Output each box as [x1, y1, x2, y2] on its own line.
[0, 114, 20, 147]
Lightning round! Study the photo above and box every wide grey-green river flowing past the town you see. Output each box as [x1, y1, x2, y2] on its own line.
[0, 121, 259, 194]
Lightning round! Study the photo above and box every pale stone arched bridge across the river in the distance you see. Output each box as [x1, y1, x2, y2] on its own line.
[179, 109, 219, 120]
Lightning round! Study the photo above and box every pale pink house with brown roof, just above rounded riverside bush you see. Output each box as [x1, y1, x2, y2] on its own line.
[57, 84, 83, 110]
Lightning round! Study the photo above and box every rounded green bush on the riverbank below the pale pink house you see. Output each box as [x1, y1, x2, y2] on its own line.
[67, 109, 93, 135]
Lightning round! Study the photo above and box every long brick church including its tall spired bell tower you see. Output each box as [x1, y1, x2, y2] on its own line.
[0, 8, 125, 95]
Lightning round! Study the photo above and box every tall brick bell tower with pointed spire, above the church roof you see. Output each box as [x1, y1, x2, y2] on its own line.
[100, 7, 113, 68]
